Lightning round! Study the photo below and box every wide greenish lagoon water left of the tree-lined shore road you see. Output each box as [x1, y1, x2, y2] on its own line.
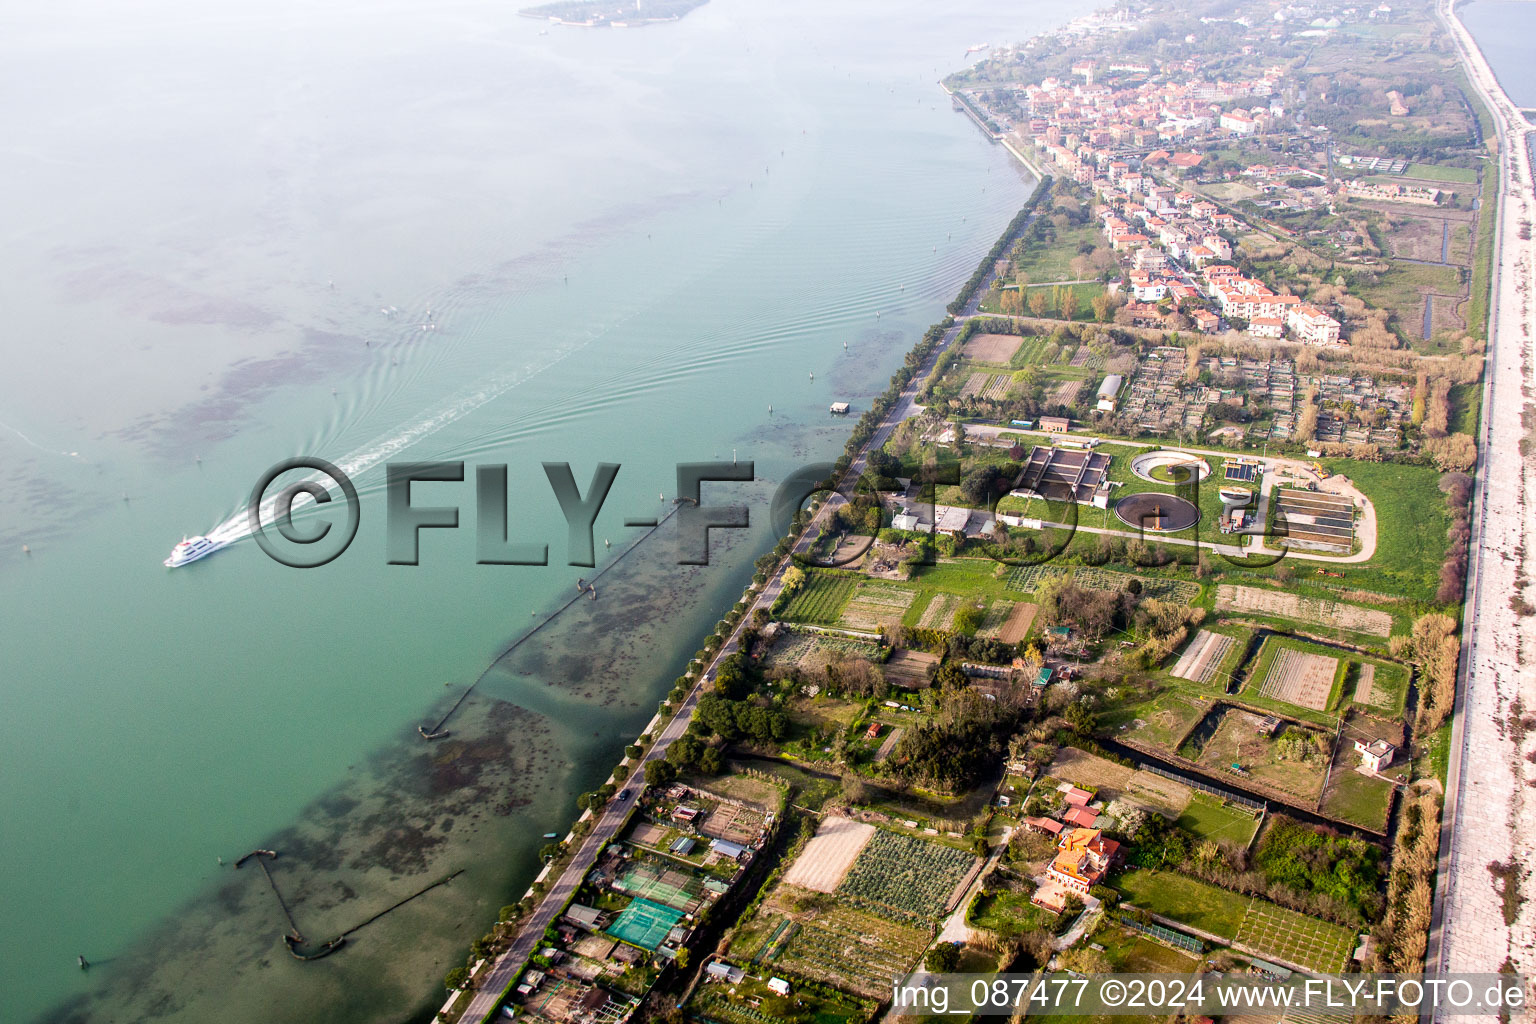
[0, 0, 1071, 1024]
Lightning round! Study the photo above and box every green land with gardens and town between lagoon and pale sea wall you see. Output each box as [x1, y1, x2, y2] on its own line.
[441, 3, 1536, 1024]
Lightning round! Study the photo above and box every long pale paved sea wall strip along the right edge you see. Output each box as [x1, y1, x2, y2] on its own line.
[1425, 0, 1536, 1000]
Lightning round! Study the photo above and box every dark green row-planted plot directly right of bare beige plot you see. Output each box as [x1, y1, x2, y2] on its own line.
[837, 829, 977, 924]
